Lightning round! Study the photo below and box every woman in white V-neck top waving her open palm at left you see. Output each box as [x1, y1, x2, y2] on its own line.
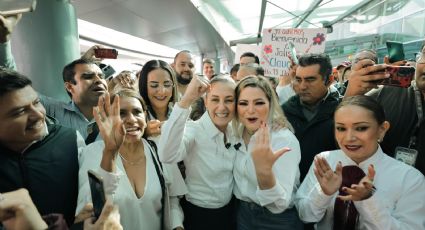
[77, 90, 185, 230]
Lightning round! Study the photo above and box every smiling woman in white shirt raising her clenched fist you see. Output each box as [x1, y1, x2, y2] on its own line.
[159, 76, 235, 230]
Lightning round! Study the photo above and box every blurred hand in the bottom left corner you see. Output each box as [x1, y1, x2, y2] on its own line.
[0, 189, 47, 230]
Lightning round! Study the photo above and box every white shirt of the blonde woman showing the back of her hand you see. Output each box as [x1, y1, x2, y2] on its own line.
[233, 128, 301, 213]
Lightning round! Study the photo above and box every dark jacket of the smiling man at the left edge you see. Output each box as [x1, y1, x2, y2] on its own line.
[0, 124, 79, 225]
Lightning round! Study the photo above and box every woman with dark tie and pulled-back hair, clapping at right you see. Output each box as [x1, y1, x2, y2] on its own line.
[295, 96, 425, 230]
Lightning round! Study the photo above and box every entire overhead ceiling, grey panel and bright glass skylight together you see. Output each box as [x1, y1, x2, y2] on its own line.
[71, 0, 407, 62]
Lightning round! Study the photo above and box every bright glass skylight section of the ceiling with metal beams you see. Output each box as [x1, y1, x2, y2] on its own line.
[191, 0, 373, 45]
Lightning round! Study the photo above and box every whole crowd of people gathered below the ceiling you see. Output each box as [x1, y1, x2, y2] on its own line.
[0, 11, 425, 230]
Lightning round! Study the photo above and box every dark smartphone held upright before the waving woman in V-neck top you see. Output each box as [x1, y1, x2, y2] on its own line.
[87, 170, 106, 220]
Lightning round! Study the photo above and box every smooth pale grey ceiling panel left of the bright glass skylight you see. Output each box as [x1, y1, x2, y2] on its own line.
[71, 0, 233, 60]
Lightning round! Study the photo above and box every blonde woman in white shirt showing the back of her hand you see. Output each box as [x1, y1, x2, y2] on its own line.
[234, 76, 302, 230]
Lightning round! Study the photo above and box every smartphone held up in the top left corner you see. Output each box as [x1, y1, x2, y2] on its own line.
[0, 0, 37, 16]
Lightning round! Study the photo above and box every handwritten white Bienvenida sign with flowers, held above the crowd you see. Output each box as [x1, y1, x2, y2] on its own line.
[259, 28, 326, 77]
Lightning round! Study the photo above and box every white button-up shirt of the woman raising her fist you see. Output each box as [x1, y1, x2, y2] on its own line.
[158, 104, 235, 208]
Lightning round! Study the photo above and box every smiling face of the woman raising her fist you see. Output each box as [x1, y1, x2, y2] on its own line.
[205, 82, 235, 132]
